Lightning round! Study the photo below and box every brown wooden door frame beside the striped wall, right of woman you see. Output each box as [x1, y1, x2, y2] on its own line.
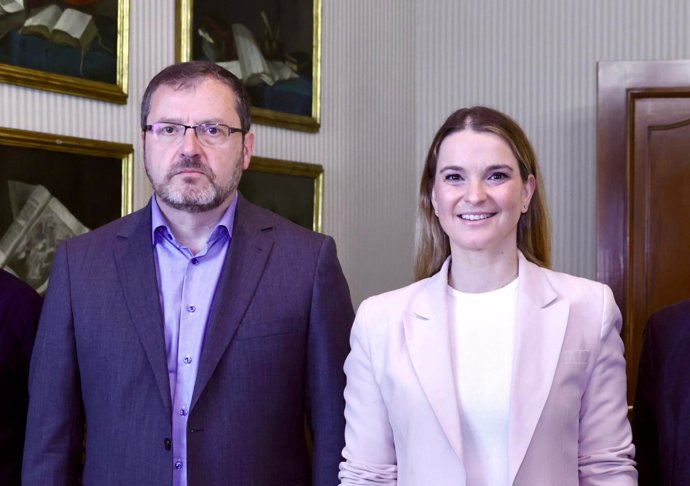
[596, 61, 690, 403]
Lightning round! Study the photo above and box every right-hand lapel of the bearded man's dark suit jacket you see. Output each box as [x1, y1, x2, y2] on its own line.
[191, 193, 273, 408]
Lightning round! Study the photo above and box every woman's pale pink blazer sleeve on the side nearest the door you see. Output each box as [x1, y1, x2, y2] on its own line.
[578, 286, 637, 486]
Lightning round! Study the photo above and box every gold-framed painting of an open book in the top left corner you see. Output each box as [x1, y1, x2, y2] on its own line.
[0, 0, 130, 104]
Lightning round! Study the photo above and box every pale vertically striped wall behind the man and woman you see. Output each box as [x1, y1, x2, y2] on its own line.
[0, 0, 690, 304]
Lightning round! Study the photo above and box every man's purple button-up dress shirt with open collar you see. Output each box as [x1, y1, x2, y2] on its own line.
[151, 196, 237, 486]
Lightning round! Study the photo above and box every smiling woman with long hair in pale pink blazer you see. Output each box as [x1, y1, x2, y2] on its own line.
[340, 107, 637, 486]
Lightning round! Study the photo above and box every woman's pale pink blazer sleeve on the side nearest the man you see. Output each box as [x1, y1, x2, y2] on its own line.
[339, 301, 398, 486]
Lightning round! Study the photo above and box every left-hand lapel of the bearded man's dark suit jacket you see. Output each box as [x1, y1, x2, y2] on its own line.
[115, 202, 172, 410]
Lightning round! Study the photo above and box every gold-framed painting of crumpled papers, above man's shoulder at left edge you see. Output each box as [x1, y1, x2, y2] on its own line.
[0, 128, 134, 292]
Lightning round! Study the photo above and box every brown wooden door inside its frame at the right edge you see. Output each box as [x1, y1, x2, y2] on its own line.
[628, 97, 690, 394]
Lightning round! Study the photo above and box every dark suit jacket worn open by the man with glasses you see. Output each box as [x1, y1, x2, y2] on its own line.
[23, 196, 353, 486]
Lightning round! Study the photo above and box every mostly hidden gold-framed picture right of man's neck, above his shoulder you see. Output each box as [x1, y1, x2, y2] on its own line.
[239, 157, 323, 231]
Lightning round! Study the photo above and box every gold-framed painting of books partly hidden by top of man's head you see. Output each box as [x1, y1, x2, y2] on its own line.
[176, 0, 321, 132]
